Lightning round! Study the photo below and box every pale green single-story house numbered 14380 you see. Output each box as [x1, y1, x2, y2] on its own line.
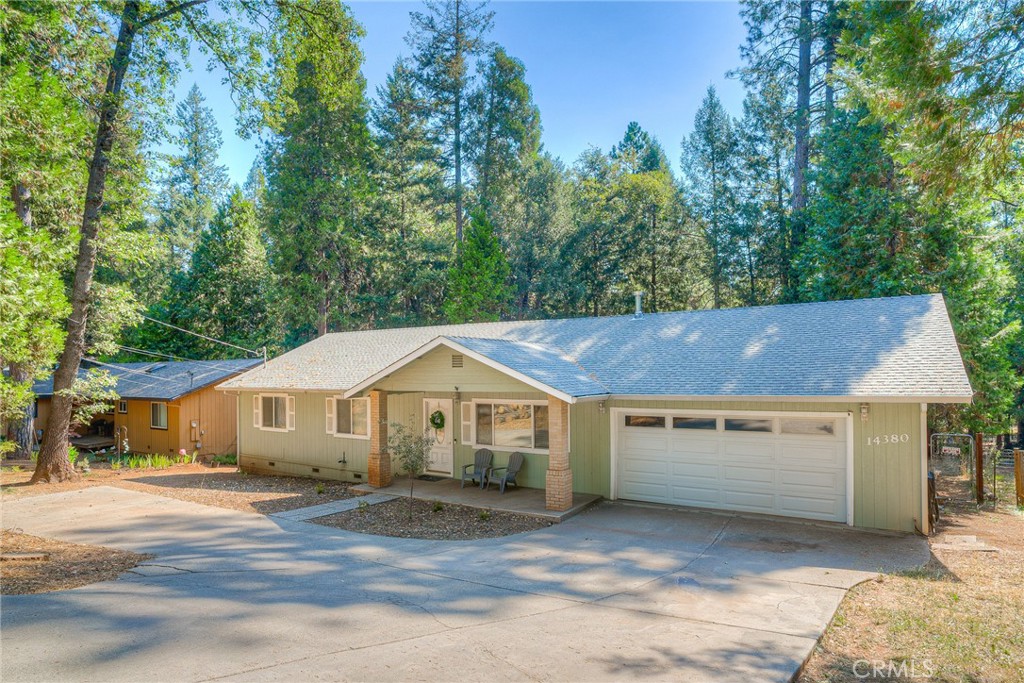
[218, 295, 972, 531]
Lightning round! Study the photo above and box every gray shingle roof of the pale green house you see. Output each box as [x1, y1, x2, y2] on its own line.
[221, 295, 972, 401]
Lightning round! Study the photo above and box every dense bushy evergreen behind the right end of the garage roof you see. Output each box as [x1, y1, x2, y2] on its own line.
[800, 109, 1016, 430]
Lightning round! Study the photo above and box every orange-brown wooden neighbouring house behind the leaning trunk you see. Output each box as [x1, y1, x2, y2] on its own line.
[33, 358, 263, 456]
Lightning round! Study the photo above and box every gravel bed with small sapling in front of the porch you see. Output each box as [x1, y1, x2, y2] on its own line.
[310, 499, 551, 541]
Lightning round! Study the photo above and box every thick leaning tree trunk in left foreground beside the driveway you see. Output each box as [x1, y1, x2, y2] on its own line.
[32, 0, 140, 483]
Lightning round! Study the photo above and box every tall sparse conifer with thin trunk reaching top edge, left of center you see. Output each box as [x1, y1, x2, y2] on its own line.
[407, 0, 494, 243]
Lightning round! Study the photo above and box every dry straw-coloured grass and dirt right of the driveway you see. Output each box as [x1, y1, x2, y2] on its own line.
[800, 464, 1024, 683]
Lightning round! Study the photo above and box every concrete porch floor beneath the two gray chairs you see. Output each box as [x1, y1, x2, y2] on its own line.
[351, 476, 601, 523]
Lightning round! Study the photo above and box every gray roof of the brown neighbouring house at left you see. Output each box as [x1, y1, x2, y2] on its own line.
[32, 358, 263, 400]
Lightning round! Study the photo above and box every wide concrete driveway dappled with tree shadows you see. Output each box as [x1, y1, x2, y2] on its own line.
[0, 487, 928, 682]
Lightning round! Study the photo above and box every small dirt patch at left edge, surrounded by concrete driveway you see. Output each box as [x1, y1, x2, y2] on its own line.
[0, 529, 153, 595]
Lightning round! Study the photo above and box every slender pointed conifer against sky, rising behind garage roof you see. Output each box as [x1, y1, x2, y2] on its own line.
[682, 86, 738, 308]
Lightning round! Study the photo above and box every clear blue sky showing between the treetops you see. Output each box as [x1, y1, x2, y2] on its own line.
[176, 1, 745, 182]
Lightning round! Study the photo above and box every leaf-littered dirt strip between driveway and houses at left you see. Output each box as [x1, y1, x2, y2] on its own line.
[0, 461, 352, 514]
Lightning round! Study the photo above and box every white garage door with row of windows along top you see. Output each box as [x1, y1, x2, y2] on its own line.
[612, 411, 847, 521]
